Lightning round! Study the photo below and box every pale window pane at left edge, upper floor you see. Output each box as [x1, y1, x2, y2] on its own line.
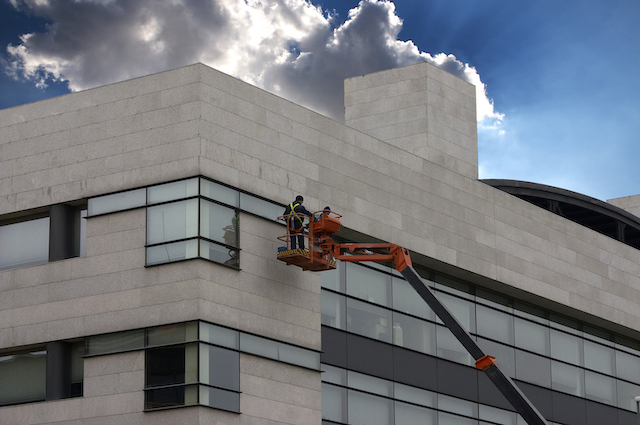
[0, 217, 49, 270]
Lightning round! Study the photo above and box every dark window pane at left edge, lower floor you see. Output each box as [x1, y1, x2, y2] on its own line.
[0, 350, 47, 406]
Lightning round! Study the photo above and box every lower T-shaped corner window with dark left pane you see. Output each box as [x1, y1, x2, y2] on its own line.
[86, 321, 320, 413]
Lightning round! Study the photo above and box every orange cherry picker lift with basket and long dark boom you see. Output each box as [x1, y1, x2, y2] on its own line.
[278, 211, 548, 425]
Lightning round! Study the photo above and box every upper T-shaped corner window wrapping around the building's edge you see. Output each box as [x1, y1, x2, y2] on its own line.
[88, 177, 282, 268]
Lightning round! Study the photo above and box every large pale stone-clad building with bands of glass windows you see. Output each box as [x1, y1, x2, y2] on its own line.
[0, 63, 640, 425]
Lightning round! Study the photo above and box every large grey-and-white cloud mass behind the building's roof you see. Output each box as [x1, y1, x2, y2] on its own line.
[7, 0, 503, 124]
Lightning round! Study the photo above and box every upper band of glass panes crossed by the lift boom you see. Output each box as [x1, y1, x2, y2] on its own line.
[321, 263, 640, 417]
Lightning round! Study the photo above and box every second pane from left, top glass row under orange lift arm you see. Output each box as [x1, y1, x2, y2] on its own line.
[346, 264, 391, 307]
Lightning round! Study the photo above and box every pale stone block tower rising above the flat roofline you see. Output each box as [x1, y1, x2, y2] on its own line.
[344, 64, 478, 179]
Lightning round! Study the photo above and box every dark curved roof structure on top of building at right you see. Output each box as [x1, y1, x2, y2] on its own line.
[481, 179, 640, 249]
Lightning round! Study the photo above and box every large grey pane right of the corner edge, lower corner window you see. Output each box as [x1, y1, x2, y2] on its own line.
[200, 344, 240, 391]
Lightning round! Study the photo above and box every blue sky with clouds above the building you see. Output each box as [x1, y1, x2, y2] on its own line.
[0, 0, 640, 200]
